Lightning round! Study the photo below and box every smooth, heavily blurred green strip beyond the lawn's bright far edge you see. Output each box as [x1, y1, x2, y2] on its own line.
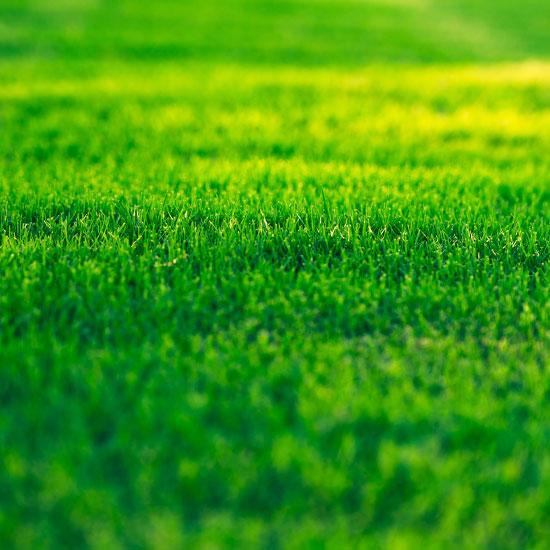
[0, 0, 550, 65]
